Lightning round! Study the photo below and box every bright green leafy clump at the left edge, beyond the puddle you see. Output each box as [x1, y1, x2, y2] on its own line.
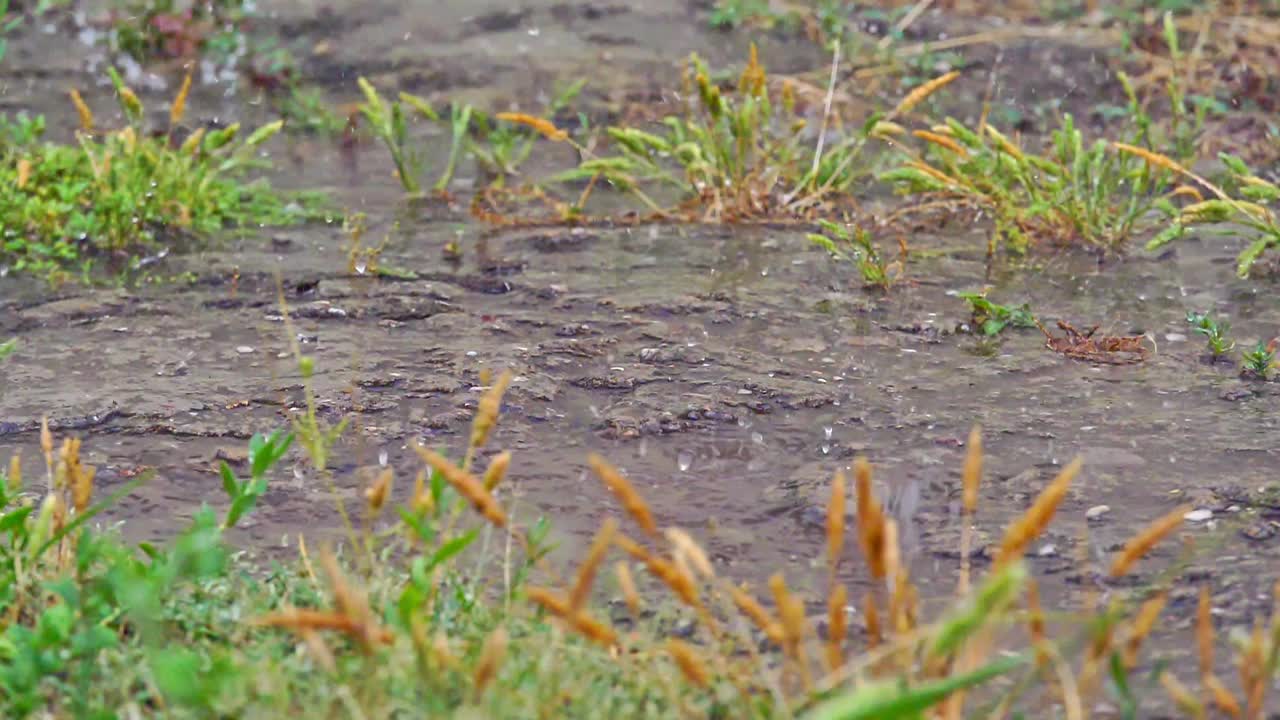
[0, 70, 317, 278]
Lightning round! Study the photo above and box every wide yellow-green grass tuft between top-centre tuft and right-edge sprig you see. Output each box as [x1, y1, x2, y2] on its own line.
[882, 18, 1207, 256]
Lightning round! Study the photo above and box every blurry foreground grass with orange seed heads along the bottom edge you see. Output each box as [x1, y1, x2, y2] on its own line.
[0, 333, 1280, 720]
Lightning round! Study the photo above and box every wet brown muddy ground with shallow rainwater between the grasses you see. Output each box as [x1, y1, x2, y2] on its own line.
[0, 0, 1280, 702]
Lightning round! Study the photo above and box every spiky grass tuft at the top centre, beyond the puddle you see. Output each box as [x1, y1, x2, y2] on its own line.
[553, 45, 955, 222]
